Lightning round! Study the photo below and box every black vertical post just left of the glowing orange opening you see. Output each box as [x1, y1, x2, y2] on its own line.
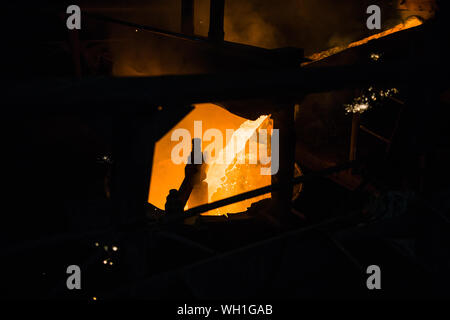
[111, 114, 155, 282]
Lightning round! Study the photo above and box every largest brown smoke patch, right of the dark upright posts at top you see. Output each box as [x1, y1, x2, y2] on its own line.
[220, 0, 400, 54]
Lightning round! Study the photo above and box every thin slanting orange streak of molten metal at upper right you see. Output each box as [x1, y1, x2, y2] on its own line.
[303, 17, 422, 65]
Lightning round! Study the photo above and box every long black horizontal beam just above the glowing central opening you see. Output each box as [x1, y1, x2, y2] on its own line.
[3, 63, 422, 112]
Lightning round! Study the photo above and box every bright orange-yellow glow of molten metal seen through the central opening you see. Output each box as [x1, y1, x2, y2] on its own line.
[148, 103, 272, 215]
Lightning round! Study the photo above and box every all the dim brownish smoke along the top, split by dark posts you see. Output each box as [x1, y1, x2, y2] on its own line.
[107, 0, 416, 75]
